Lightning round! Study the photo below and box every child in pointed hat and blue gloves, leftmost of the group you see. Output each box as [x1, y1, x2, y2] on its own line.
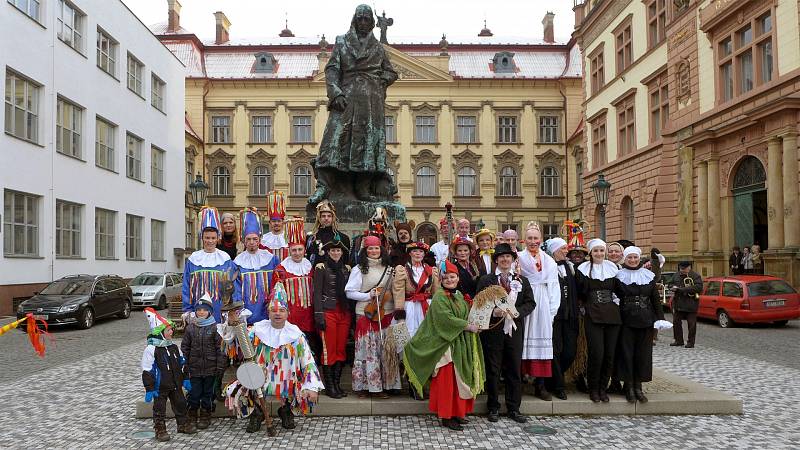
[142, 308, 197, 442]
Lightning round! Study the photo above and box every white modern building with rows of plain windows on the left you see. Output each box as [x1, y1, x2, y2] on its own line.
[0, 0, 185, 316]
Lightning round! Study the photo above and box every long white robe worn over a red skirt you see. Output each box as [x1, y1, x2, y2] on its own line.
[517, 250, 561, 360]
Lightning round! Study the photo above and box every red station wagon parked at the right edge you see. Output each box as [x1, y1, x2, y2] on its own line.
[697, 275, 800, 328]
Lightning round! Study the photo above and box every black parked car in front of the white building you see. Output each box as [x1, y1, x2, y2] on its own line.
[17, 275, 132, 329]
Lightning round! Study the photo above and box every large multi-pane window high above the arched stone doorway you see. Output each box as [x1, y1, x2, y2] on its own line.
[717, 11, 775, 102]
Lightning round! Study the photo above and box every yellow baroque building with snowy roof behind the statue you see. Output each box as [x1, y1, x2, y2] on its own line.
[153, 5, 583, 247]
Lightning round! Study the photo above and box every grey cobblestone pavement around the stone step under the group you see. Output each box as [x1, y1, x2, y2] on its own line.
[0, 313, 800, 449]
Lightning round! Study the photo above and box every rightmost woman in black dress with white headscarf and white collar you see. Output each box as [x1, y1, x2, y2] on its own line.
[616, 246, 672, 403]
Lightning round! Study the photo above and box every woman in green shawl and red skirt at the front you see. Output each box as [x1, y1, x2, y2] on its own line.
[403, 261, 486, 431]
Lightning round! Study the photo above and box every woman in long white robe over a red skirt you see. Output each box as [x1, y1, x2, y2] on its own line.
[512, 222, 561, 401]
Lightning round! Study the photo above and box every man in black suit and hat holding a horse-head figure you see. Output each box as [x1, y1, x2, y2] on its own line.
[477, 244, 536, 423]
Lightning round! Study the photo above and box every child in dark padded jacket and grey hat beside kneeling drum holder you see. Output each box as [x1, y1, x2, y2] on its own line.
[181, 293, 228, 430]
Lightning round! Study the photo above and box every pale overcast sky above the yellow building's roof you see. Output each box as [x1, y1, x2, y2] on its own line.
[123, 0, 574, 42]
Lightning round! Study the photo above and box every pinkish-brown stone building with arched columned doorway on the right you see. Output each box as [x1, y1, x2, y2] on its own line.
[575, 0, 800, 286]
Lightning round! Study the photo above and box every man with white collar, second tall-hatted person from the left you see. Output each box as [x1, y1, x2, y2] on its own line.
[233, 208, 280, 323]
